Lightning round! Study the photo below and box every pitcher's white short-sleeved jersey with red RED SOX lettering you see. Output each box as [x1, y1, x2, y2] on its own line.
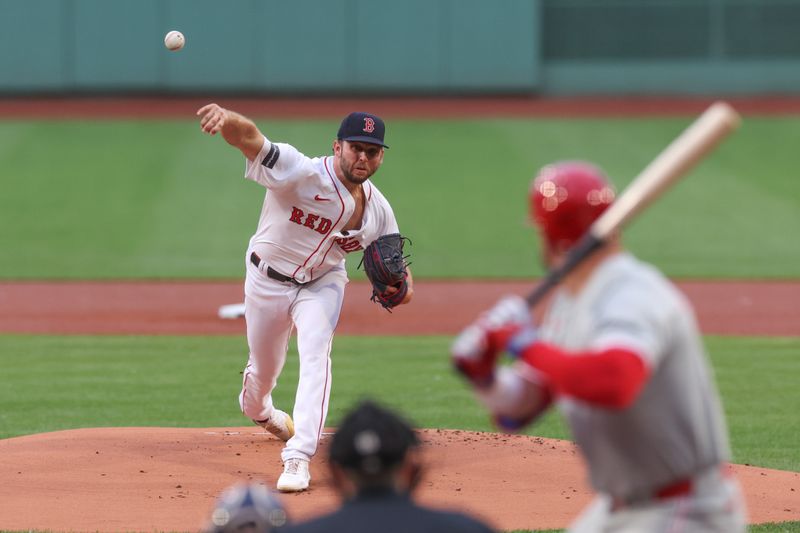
[245, 137, 399, 283]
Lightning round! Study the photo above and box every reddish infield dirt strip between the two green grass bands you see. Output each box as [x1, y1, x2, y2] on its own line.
[0, 280, 800, 336]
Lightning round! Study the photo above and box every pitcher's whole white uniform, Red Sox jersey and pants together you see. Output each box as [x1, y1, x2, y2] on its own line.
[239, 138, 398, 461]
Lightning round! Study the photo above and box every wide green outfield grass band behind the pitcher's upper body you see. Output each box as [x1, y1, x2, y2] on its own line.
[0, 117, 800, 279]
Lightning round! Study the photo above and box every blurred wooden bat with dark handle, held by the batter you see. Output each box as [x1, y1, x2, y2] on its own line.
[526, 102, 741, 307]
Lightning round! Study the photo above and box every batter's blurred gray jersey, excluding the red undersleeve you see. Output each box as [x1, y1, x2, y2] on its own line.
[541, 253, 730, 500]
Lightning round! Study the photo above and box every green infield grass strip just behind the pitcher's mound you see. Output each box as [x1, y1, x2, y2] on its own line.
[0, 335, 800, 471]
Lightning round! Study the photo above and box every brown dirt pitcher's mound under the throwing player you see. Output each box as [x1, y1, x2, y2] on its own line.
[0, 427, 800, 532]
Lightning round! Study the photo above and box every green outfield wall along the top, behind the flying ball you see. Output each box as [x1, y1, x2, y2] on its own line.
[0, 0, 800, 95]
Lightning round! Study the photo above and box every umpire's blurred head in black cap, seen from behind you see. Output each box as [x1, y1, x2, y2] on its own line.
[329, 400, 420, 497]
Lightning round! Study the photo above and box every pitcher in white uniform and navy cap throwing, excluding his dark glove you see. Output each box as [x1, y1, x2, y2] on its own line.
[197, 104, 414, 492]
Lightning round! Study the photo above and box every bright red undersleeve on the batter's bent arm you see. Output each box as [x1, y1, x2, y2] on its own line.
[522, 342, 650, 409]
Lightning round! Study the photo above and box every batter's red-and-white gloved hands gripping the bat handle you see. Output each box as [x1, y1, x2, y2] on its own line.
[450, 296, 532, 387]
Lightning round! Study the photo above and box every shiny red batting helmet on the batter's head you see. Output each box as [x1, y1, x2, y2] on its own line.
[530, 161, 614, 248]
